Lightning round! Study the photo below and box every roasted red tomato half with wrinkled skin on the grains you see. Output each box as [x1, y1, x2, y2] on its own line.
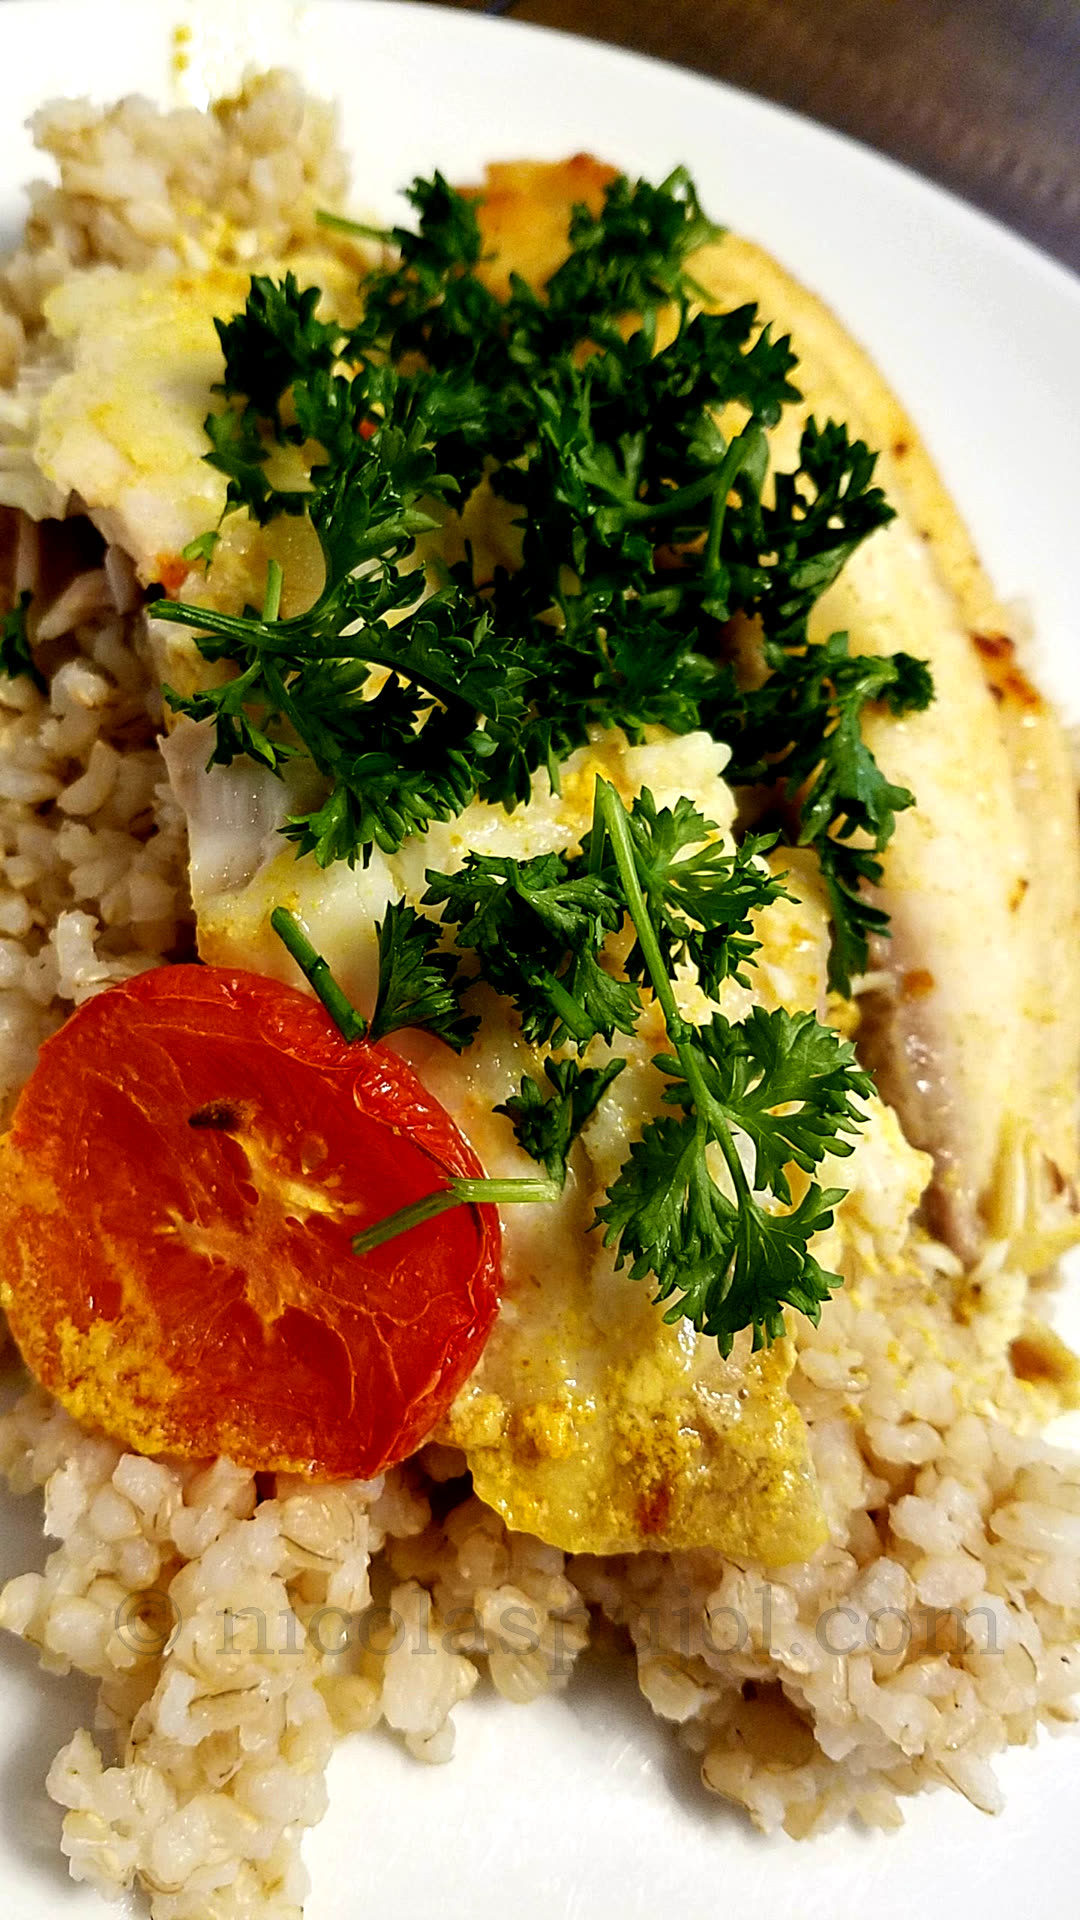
[0, 966, 500, 1478]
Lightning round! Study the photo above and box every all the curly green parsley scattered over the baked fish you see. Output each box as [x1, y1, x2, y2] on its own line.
[164, 171, 932, 1354]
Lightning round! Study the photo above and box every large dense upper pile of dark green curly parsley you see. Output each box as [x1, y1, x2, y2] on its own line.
[158, 169, 910, 936]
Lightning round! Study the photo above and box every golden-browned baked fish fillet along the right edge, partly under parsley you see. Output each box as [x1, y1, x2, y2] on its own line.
[470, 156, 1080, 1261]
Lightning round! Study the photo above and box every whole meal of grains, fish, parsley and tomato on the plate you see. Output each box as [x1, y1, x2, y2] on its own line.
[0, 73, 1080, 1920]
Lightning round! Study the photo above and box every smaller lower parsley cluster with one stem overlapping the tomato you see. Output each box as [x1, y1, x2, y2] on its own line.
[343, 780, 872, 1354]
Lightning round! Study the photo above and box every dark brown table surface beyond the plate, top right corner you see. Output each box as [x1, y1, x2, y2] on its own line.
[424, 0, 1080, 271]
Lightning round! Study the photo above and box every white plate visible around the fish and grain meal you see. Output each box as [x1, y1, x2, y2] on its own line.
[0, 0, 1080, 1920]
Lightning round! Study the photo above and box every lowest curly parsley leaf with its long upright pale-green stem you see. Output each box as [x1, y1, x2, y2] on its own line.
[596, 783, 871, 1354]
